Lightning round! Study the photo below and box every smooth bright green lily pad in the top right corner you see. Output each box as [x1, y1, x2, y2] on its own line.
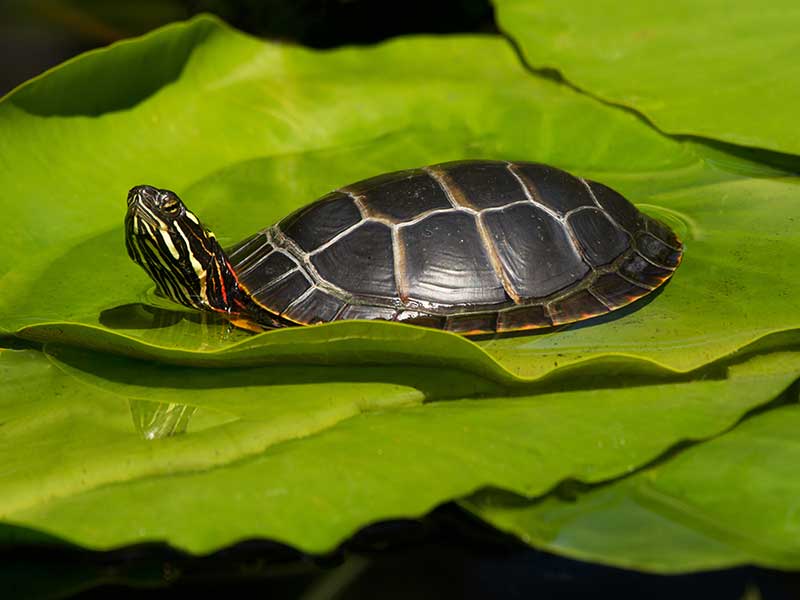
[494, 0, 800, 154]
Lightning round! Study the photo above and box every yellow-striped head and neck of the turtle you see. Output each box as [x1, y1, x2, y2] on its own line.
[125, 185, 238, 312]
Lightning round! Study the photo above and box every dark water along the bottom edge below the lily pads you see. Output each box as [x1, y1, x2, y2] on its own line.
[0, 505, 800, 600]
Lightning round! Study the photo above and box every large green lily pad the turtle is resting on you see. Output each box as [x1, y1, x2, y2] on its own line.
[0, 18, 800, 383]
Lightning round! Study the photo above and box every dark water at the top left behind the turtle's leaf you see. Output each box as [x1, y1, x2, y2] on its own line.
[0, 0, 497, 96]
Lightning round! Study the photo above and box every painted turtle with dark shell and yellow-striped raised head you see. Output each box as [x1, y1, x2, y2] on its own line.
[125, 160, 683, 336]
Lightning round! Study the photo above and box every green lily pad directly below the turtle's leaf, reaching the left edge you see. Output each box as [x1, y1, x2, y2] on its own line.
[0, 347, 800, 552]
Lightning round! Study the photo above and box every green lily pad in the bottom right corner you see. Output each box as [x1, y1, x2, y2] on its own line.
[463, 384, 800, 573]
